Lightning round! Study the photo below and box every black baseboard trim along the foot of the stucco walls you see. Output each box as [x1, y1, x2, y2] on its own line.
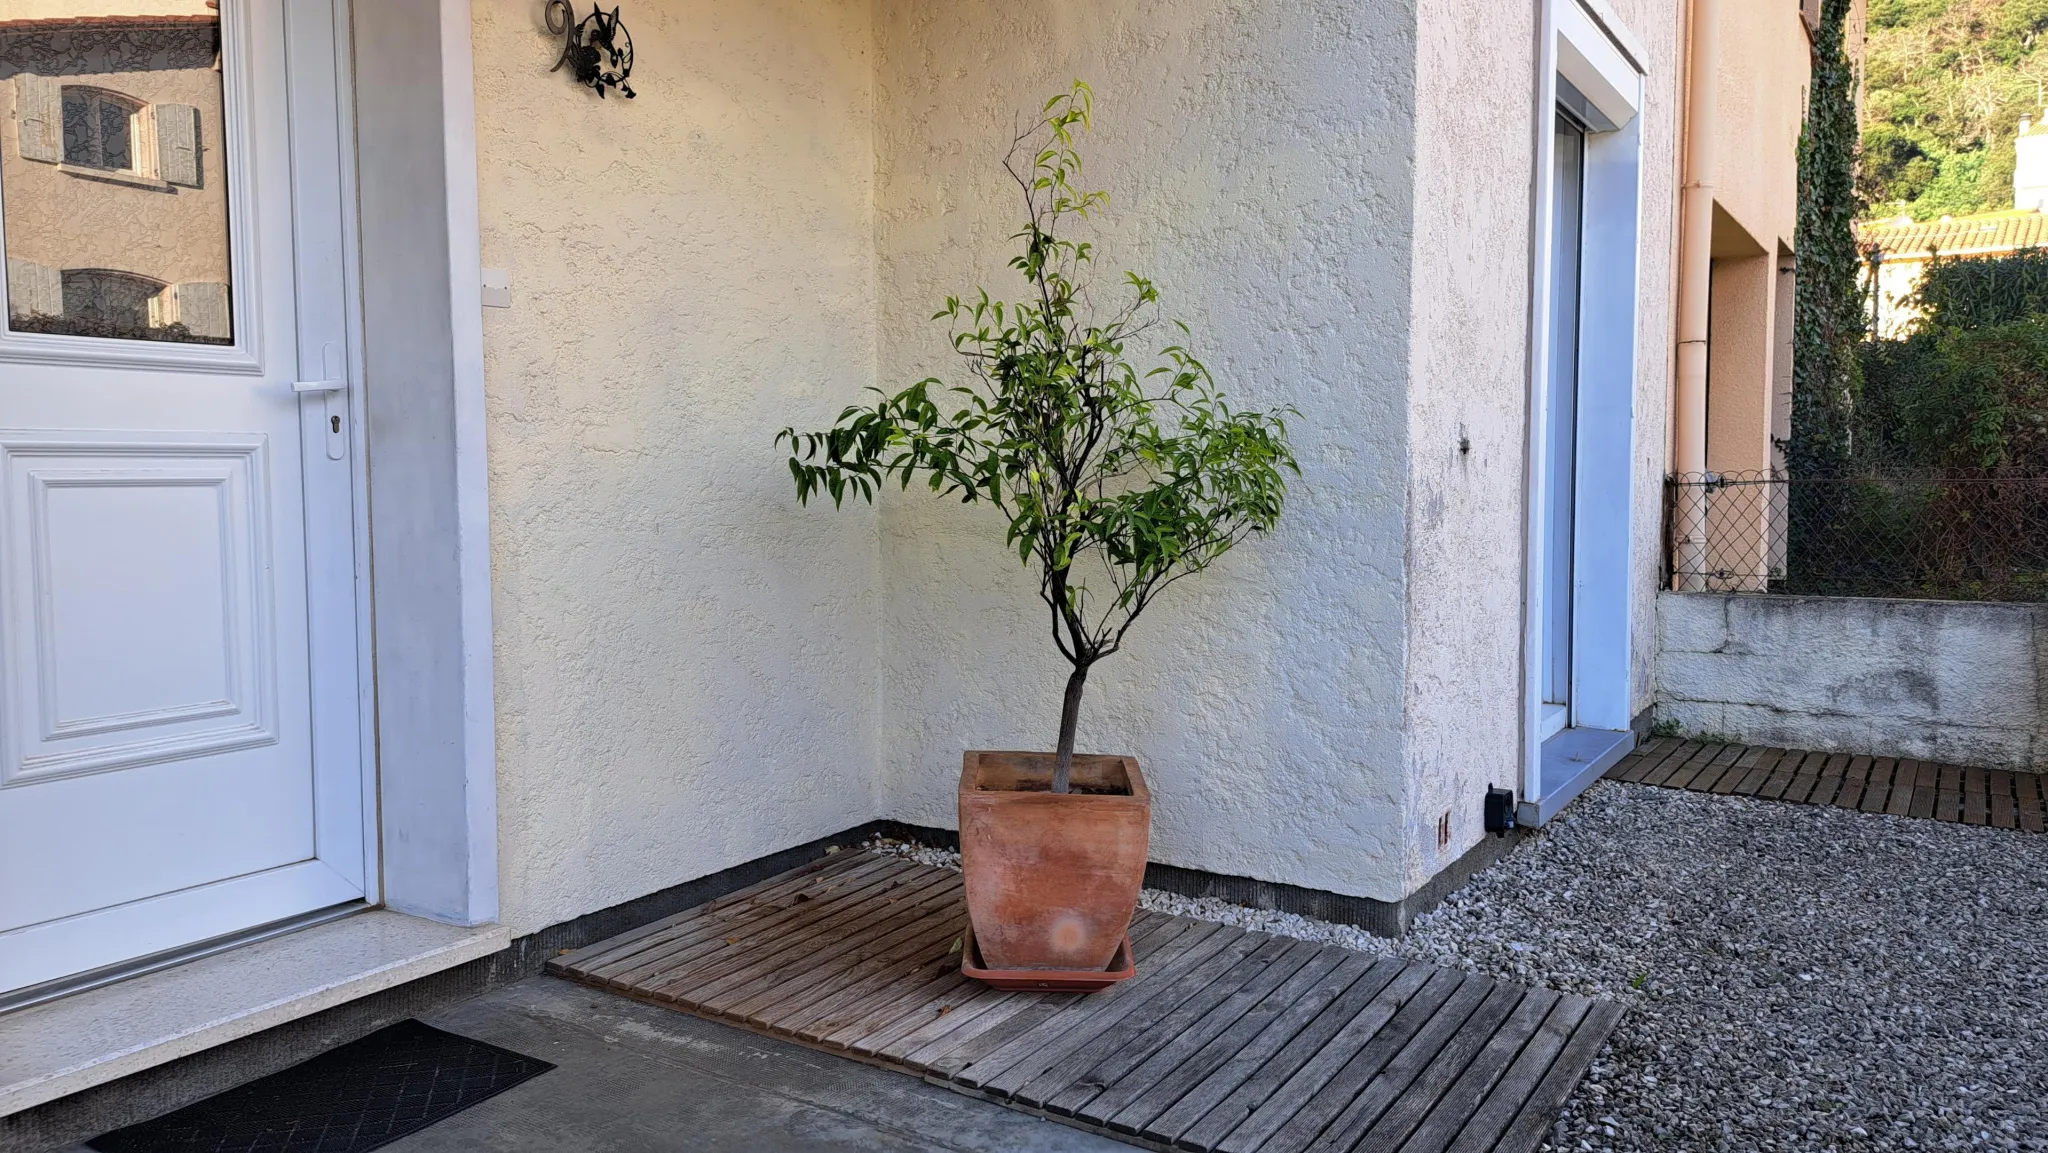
[0, 821, 1520, 1153]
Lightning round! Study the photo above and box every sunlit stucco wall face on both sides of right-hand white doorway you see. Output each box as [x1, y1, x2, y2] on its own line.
[1403, 0, 1677, 889]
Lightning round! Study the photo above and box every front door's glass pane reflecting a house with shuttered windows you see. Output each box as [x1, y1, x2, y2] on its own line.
[0, 0, 233, 344]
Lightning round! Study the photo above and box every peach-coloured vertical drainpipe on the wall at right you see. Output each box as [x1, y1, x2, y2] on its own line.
[1671, 0, 1720, 592]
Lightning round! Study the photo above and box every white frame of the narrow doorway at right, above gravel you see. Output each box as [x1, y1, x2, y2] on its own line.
[1522, 0, 1642, 823]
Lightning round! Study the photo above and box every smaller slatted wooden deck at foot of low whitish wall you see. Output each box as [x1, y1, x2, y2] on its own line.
[1606, 737, 2048, 834]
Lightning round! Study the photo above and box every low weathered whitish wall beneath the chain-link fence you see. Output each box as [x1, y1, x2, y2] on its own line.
[1657, 592, 2048, 770]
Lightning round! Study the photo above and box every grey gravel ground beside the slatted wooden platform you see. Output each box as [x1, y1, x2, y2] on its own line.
[864, 782, 2048, 1153]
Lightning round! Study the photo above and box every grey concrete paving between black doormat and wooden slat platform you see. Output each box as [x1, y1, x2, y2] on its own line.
[387, 977, 1128, 1153]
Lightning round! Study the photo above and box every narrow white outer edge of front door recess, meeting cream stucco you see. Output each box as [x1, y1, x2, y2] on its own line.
[440, 0, 498, 924]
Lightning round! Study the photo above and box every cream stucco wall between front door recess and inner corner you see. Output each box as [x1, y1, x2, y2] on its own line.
[475, 0, 881, 932]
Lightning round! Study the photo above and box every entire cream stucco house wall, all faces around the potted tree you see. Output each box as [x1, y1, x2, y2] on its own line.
[475, 0, 1677, 928]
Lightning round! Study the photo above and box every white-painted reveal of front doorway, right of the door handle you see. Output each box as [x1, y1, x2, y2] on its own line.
[350, 0, 498, 926]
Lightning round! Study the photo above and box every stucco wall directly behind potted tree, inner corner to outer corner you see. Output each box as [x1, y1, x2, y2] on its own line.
[868, 0, 1415, 899]
